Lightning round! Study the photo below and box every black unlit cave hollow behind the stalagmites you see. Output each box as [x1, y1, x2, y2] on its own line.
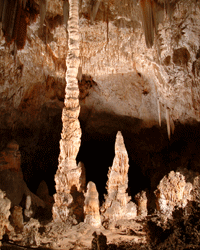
[1, 106, 200, 211]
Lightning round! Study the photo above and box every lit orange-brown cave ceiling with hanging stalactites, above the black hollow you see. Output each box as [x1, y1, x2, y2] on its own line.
[0, 0, 200, 133]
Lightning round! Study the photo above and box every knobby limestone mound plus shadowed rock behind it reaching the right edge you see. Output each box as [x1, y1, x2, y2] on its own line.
[155, 168, 200, 218]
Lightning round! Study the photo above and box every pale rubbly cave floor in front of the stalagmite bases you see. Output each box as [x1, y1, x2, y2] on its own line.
[1, 220, 146, 250]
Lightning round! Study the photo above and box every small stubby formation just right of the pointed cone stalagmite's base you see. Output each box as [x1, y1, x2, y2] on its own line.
[135, 191, 148, 217]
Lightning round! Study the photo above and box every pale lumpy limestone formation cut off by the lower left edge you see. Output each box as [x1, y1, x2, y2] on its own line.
[0, 190, 12, 247]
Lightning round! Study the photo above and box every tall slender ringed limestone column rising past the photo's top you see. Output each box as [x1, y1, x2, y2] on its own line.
[53, 0, 84, 222]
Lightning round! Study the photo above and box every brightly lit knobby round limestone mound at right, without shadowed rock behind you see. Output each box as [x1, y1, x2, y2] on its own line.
[155, 171, 193, 218]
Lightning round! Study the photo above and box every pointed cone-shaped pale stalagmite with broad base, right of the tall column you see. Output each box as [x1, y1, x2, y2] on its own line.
[101, 132, 137, 222]
